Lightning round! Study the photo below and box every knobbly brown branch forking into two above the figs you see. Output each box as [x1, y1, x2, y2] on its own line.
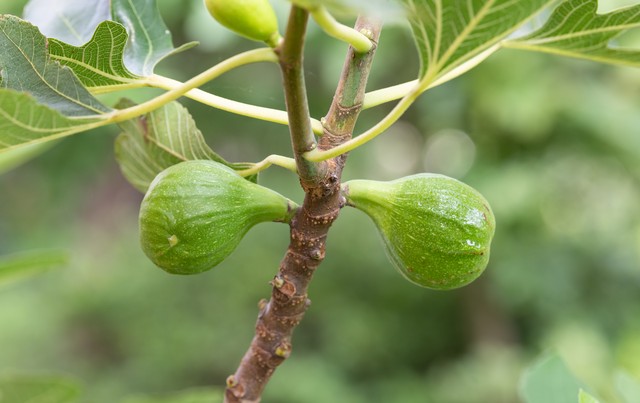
[225, 12, 381, 403]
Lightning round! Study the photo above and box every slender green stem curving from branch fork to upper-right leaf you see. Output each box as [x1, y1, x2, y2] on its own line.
[304, 82, 422, 162]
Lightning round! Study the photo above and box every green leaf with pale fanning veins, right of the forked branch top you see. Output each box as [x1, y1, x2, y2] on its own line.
[402, 0, 555, 90]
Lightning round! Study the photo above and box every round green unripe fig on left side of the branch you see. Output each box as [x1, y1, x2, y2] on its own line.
[140, 161, 296, 274]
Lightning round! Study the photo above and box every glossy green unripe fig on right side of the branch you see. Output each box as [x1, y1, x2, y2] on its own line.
[344, 174, 495, 290]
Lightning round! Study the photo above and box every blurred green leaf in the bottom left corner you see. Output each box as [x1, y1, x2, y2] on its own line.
[0, 375, 80, 403]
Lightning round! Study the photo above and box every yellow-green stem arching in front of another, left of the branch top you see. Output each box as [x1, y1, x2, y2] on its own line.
[107, 48, 278, 123]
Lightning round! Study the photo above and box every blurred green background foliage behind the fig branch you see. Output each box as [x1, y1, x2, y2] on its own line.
[0, 0, 640, 403]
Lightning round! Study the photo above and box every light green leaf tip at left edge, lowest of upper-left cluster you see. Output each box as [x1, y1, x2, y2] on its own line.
[0, 89, 104, 153]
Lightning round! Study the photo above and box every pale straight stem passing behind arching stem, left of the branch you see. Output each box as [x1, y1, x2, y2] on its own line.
[147, 74, 322, 135]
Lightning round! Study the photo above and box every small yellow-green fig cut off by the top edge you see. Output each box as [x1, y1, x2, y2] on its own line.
[204, 0, 280, 47]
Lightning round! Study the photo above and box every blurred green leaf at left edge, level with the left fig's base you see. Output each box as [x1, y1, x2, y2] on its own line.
[0, 250, 69, 288]
